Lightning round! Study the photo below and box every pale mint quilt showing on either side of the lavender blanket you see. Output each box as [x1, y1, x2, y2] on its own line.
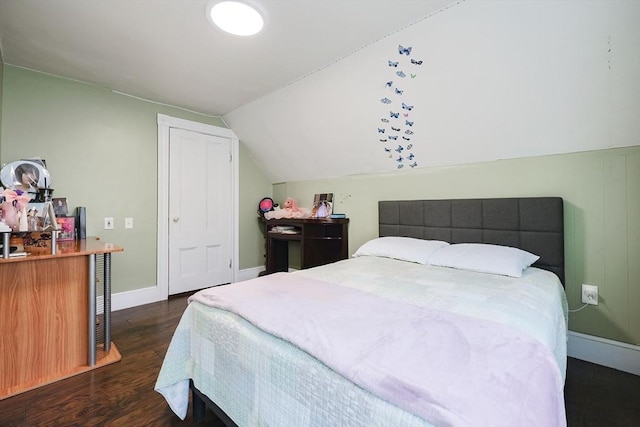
[155, 257, 567, 426]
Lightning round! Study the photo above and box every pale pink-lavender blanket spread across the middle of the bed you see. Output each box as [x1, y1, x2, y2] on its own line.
[190, 273, 566, 426]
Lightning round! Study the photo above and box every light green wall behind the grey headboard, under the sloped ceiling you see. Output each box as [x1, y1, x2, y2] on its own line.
[274, 146, 640, 345]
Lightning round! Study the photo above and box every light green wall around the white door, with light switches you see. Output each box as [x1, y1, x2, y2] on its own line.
[0, 65, 271, 293]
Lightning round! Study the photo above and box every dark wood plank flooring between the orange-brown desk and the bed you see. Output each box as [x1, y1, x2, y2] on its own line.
[0, 296, 218, 427]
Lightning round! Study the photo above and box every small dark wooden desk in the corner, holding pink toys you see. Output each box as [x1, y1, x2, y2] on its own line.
[264, 218, 349, 274]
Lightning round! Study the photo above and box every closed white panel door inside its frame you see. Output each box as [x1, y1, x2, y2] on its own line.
[169, 128, 232, 295]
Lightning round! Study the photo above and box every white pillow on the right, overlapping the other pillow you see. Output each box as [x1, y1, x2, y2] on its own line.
[429, 243, 540, 277]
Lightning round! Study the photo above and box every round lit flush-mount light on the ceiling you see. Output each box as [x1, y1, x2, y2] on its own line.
[209, 1, 264, 36]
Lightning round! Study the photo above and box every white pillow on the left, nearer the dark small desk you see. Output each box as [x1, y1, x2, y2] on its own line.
[353, 236, 449, 264]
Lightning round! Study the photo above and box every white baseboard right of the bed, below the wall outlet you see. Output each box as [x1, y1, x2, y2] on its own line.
[567, 331, 640, 375]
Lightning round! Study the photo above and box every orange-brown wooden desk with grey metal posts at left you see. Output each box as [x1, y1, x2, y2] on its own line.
[0, 238, 123, 399]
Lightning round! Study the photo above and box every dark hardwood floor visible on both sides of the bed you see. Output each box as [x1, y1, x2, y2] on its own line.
[0, 296, 640, 427]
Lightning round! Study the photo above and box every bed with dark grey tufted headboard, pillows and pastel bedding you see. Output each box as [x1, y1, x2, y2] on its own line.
[155, 197, 567, 427]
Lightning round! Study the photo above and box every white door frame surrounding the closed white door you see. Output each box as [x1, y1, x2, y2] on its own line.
[156, 114, 239, 299]
